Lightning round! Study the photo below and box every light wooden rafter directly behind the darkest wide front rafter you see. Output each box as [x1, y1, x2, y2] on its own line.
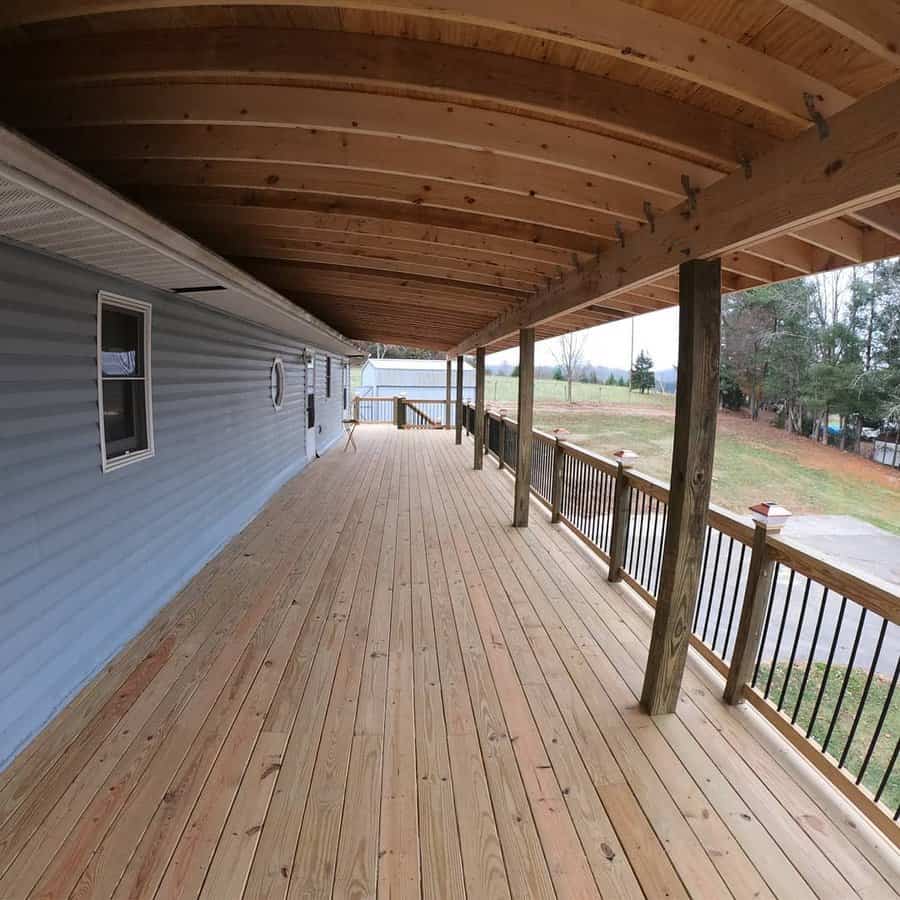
[10, 84, 720, 199]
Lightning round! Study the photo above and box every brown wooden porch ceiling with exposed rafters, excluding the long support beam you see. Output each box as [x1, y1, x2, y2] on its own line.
[0, 0, 900, 350]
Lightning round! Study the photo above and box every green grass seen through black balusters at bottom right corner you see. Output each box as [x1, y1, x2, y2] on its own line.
[757, 662, 900, 813]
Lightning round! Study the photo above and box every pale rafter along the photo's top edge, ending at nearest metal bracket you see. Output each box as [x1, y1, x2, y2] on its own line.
[0, 0, 853, 122]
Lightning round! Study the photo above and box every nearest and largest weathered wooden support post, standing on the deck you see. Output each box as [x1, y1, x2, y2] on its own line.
[641, 259, 722, 715]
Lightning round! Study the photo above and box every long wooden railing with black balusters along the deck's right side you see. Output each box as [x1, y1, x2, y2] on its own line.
[466, 405, 900, 844]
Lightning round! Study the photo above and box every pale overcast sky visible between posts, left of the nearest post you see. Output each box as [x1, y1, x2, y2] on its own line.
[487, 306, 678, 370]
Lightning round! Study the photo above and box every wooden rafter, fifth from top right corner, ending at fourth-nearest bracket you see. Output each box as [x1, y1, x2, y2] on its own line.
[30, 125, 684, 222]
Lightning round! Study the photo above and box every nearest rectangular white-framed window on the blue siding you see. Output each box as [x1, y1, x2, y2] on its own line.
[97, 292, 153, 472]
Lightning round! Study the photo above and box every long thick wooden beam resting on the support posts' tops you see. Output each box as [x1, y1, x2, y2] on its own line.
[454, 82, 900, 351]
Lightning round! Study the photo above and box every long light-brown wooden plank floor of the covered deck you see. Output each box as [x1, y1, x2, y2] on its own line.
[0, 426, 900, 900]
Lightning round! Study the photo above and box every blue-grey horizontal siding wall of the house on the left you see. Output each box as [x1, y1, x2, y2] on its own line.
[0, 244, 341, 768]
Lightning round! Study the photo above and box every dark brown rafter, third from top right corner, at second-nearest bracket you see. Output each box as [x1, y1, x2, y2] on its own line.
[0, 28, 772, 169]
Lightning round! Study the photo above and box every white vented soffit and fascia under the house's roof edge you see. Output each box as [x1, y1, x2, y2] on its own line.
[0, 127, 360, 355]
